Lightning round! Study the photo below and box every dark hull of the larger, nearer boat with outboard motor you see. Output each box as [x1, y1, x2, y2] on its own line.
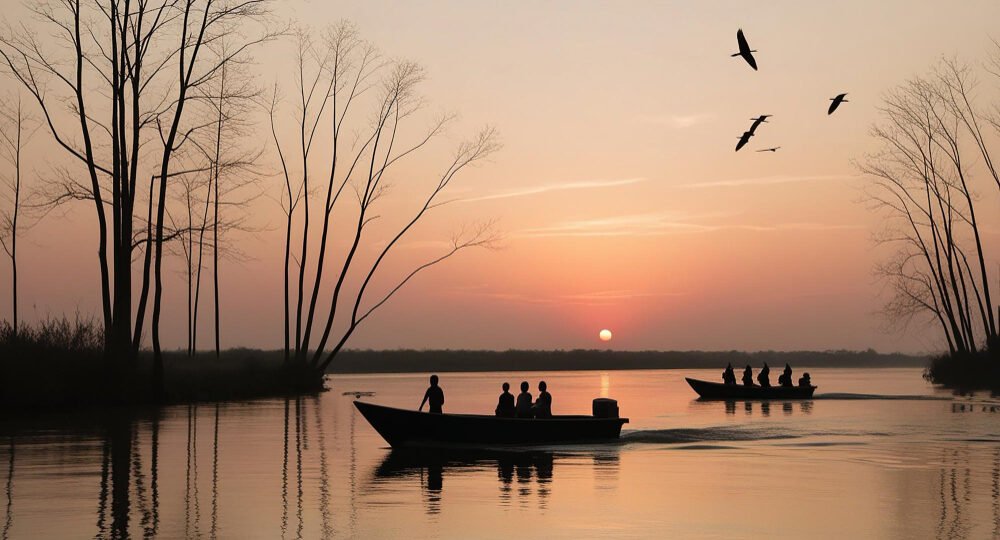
[354, 401, 628, 448]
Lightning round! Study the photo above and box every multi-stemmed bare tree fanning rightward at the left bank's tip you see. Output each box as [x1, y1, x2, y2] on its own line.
[270, 23, 499, 382]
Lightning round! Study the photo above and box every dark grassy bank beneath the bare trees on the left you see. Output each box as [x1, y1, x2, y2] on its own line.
[0, 318, 322, 409]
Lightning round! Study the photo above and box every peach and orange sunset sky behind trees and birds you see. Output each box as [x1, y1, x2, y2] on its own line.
[0, 0, 1000, 352]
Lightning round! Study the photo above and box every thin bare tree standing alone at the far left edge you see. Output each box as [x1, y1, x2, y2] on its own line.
[0, 96, 34, 338]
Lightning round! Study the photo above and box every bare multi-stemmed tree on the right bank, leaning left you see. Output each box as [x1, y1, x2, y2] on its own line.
[860, 61, 997, 354]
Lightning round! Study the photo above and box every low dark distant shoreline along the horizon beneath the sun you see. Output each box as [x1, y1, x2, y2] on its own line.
[322, 349, 930, 374]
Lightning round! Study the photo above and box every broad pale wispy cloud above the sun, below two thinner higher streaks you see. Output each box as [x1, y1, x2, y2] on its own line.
[514, 213, 864, 238]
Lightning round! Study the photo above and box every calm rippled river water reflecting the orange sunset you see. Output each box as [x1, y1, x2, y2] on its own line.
[0, 369, 1000, 539]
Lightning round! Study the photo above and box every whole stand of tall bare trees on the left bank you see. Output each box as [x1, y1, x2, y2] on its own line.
[0, 0, 500, 398]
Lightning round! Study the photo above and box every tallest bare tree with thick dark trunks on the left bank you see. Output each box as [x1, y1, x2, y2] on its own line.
[0, 0, 273, 395]
